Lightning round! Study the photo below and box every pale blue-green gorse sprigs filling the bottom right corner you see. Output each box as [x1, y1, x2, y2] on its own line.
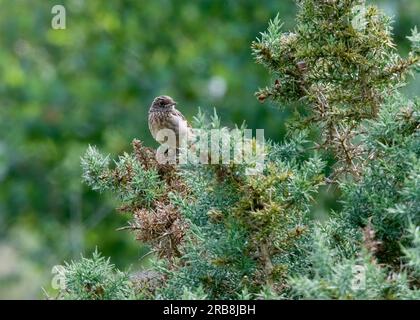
[289, 225, 420, 299]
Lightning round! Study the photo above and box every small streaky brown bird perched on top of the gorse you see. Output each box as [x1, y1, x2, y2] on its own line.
[149, 96, 193, 149]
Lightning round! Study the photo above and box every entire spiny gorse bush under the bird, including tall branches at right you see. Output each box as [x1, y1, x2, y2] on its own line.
[55, 0, 420, 299]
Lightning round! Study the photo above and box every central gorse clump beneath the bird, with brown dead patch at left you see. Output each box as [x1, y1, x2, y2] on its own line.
[82, 111, 324, 298]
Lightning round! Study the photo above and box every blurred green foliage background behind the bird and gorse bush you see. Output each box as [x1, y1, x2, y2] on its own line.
[0, 0, 420, 299]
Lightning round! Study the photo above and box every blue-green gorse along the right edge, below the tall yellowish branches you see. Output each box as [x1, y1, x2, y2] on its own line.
[341, 96, 420, 267]
